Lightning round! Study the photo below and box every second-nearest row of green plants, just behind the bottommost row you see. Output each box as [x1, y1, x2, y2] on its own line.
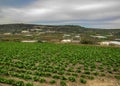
[0, 67, 94, 82]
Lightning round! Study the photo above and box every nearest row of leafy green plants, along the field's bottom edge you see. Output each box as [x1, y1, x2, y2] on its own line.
[0, 77, 87, 86]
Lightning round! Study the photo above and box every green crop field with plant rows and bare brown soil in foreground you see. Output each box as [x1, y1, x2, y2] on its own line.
[0, 42, 120, 86]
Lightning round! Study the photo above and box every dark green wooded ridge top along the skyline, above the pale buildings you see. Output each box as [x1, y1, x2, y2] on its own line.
[0, 24, 120, 36]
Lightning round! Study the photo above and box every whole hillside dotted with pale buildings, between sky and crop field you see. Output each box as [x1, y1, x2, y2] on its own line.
[0, 24, 120, 44]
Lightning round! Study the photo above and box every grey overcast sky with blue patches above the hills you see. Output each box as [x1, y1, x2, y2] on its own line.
[0, 0, 120, 29]
